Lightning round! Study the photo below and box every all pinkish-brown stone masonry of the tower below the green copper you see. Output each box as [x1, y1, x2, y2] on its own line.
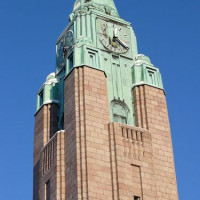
[33, 66, 178, 200]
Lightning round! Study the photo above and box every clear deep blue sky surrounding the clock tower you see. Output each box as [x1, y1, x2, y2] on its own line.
[0, 0, 200, 200]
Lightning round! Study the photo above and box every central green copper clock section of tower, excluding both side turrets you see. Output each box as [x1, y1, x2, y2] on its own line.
[56, 0, 138, 125]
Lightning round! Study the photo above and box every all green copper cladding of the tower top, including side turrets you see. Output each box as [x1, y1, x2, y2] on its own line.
[37, 0, 163, 129]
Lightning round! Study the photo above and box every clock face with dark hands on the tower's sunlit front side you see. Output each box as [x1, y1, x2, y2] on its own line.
[98, 22, 130, 54]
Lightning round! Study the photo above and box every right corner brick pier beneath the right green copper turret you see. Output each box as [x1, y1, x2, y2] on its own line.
[133, 85, 178, 200]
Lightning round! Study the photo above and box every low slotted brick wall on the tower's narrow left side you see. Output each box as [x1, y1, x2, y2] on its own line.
[39, 131, 65, 200]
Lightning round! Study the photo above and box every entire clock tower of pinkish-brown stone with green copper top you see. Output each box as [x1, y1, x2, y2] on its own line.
[33, 0, 178, 200]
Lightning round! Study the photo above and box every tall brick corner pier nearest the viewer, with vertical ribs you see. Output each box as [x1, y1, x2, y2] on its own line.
[65, 67, 112, 200]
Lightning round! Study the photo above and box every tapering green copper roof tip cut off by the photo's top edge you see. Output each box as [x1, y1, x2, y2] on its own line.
[73, 0, 119, 17]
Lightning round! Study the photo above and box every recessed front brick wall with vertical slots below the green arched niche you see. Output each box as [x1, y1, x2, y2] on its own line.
[109, 123, 157, 200]
